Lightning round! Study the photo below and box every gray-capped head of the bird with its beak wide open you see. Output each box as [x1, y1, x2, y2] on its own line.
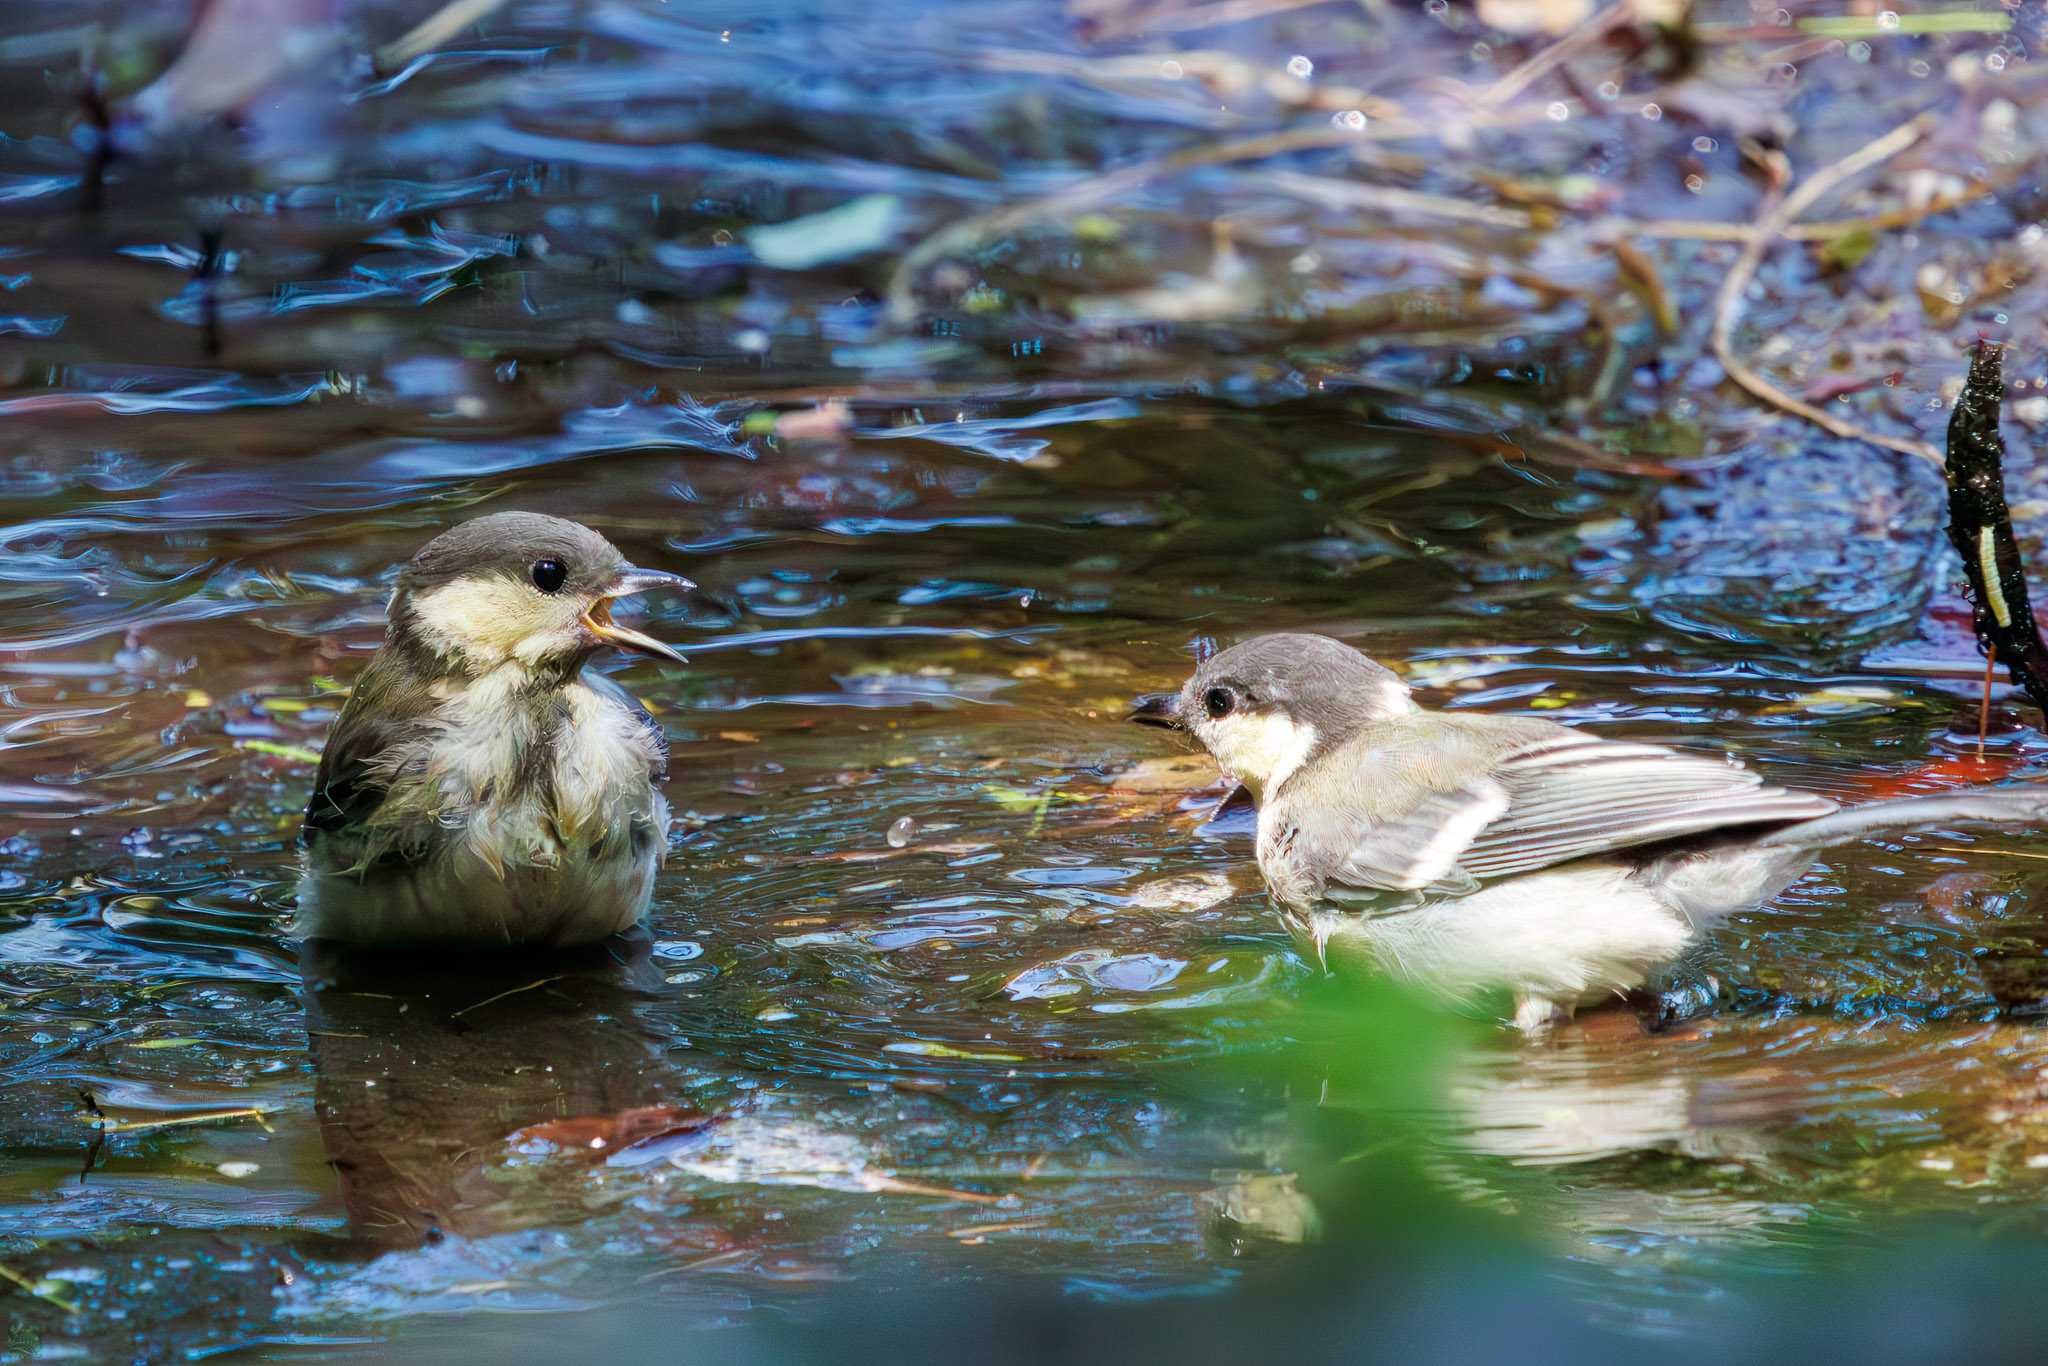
[389, 512, 696, 676]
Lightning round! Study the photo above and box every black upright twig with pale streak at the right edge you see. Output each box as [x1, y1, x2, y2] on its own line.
[1946, 342, 2048, 713]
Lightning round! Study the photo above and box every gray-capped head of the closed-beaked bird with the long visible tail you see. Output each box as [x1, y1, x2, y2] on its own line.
[1130, 635, 1415, 801]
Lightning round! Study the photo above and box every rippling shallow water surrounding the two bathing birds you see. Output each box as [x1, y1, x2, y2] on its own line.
[0, 2, 2048, 1358]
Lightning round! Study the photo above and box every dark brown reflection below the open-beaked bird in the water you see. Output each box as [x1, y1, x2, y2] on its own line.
[303, 940, 713, 1247]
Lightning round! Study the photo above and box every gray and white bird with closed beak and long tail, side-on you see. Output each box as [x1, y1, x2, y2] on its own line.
[1133, 635, 2048, 1030]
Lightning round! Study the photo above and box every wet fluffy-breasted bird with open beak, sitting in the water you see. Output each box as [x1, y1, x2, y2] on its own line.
[293, 512, 694, 946]
